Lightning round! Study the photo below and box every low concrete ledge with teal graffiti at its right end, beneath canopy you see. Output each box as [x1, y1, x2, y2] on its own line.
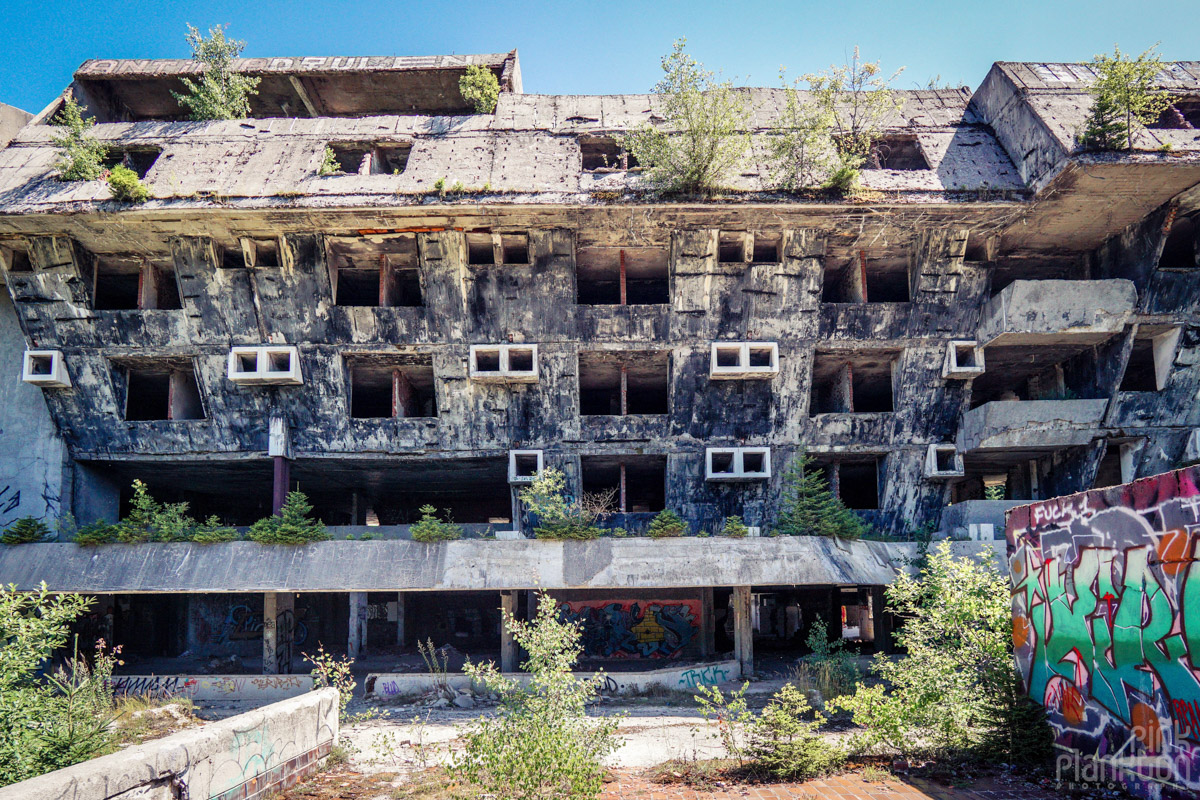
[366, 661, 740, 699]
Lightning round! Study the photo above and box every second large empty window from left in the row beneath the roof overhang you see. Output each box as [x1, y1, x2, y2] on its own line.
[325, 234, 424, 307]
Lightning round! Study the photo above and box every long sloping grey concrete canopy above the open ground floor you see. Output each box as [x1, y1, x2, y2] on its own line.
[0, 536, 914, 593]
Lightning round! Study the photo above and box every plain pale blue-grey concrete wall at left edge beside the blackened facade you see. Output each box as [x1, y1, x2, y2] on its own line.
[0, 291, 71, 530]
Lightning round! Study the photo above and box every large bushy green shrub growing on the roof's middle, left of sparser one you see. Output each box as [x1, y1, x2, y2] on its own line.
[622, 38, 750, 196]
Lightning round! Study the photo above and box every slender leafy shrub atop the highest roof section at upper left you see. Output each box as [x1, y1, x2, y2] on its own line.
[170, 25, 259, 120]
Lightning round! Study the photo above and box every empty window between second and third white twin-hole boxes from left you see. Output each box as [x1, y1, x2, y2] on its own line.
[347, 355, 438, 420]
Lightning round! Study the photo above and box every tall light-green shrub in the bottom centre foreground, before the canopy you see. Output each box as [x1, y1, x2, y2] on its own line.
[451, 594, 619, 800]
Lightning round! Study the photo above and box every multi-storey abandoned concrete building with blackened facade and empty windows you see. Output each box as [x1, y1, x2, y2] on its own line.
[0, 52, 1200, 673]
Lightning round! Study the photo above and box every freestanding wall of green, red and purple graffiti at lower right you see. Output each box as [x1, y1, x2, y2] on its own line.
[1008, 467, 1200, 800]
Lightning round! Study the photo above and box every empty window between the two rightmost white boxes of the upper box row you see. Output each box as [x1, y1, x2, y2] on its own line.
[809, 351, 898, 415]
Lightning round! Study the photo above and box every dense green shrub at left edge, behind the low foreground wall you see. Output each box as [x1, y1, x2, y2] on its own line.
[0, 583, 115, 786]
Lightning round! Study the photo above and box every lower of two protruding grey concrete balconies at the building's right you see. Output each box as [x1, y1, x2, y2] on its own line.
[956, 399, 1108, 452]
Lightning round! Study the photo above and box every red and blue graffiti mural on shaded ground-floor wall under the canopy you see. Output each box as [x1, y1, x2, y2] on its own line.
[558, 600, 701, 658]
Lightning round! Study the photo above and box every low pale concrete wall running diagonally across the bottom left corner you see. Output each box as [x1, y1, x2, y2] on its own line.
[0, 688, 338, 800]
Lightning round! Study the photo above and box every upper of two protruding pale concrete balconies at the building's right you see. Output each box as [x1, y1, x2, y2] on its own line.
[977, 279, 1138, 345]
